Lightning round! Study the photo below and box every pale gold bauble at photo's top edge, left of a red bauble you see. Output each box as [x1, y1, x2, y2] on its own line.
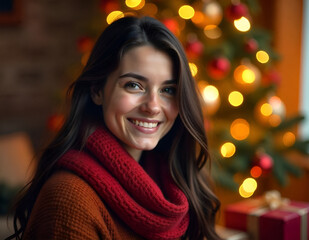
[202, 0, 223, 25]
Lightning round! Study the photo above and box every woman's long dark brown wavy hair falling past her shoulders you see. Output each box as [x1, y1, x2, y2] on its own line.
[10, 17, 220, 240]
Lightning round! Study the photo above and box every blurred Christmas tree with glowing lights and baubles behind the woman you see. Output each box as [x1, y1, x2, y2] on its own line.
[50, 0, 309, 197]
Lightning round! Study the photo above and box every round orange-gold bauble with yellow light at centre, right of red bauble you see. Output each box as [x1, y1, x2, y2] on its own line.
[234, 59, 261, 93]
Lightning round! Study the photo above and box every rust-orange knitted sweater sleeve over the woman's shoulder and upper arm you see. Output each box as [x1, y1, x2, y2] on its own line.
[23, 172, 120, 240]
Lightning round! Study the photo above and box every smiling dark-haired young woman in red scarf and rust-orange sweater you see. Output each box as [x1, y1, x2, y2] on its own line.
[11, 17, 219, 240]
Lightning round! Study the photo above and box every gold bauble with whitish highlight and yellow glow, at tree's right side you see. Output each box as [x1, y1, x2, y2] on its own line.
[255, 96, 285, 127]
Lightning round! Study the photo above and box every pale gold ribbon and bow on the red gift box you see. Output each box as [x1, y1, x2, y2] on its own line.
[247, 190, 308, 240]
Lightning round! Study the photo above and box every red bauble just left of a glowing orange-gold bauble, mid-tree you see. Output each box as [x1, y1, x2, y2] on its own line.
[206, 57, 231, 80]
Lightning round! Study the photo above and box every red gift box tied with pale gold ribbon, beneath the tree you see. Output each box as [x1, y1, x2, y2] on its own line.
[225, 197, 309, 240]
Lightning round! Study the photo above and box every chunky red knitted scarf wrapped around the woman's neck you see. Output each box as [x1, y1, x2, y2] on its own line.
[58, 128, 189, 239]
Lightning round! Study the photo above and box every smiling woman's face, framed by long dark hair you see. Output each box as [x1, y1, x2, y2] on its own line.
[93, 46, 178, 161]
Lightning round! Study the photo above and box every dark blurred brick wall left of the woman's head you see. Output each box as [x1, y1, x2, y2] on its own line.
[0, 0, 93, 150]
